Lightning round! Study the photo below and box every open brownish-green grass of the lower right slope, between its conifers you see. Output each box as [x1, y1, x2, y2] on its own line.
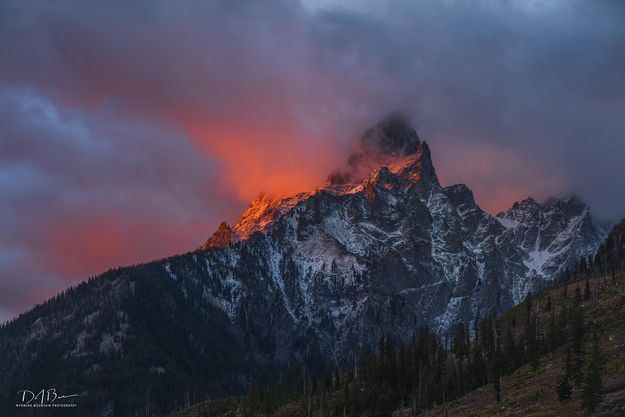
[172, 273, 625, 417]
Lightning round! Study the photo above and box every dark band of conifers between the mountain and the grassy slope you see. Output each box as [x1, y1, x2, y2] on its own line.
[245, 274, 616, 417]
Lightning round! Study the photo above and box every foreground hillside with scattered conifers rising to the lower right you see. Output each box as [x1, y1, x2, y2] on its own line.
[172, 272, 625, 417]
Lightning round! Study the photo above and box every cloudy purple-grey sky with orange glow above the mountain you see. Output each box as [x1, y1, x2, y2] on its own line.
[0, 0, 625, 322]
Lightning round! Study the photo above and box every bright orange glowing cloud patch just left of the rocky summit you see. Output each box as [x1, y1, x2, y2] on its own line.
[180, 117, 343, 201]
